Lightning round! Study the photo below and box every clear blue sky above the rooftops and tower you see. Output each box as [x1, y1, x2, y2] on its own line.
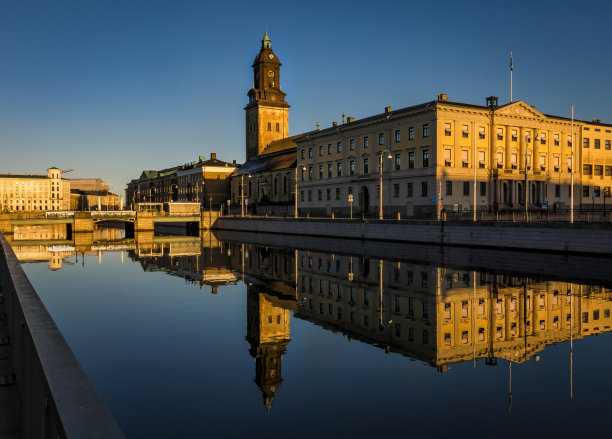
[0, 0, 612, 196]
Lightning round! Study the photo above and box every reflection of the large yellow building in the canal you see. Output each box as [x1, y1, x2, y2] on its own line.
[231, 244, 612, 372]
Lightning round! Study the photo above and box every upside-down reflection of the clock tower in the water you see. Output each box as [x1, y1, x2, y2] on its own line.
[246, 287, 291, 414]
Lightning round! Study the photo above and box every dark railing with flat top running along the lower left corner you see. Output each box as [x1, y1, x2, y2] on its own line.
[0, 235, 123, 439]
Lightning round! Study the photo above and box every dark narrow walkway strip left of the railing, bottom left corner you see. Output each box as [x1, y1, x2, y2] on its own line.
[0, 288, 22, 439]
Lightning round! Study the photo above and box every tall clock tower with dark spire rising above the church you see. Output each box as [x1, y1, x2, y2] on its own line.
[244, 31, 289, 161]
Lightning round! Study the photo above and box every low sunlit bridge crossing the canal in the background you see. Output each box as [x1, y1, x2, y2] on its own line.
[0, 210, 219, 235]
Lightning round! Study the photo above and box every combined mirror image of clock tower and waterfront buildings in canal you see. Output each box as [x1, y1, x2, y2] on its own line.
[117, 234, 612, 413]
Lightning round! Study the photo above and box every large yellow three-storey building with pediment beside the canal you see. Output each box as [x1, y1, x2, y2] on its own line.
[295, 94, 612, 217]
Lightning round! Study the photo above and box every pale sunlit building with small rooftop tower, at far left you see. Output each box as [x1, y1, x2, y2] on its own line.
[0, 168, 70, 213]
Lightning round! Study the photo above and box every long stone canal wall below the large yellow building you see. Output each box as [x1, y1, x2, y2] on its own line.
[213, 216, 612, 256]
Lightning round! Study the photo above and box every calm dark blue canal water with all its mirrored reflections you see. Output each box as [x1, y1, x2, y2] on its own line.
[13, 232, 612, 438]
